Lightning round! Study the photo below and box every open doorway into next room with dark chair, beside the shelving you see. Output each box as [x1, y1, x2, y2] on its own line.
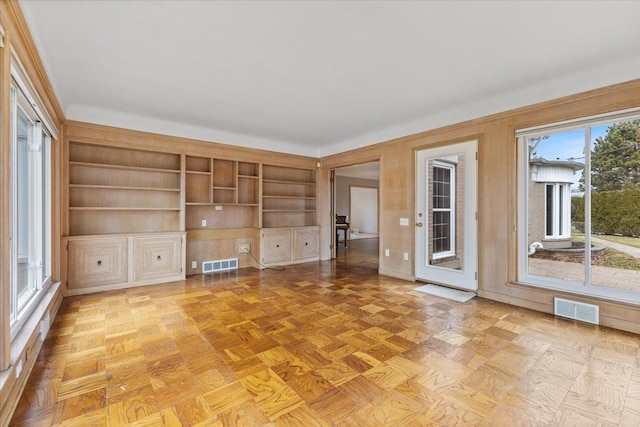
[332, 161, 380, 270]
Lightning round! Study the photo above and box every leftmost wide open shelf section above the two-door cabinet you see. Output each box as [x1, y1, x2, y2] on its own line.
[68, 142, 181, 236]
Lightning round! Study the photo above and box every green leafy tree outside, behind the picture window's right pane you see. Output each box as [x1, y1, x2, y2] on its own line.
[580, 120, 640, 191]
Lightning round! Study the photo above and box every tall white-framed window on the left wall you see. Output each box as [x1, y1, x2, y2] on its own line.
[9, 79, 51, 337]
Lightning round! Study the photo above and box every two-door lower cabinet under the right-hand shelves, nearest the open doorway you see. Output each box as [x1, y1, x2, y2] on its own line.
[260, 226, 320, 267]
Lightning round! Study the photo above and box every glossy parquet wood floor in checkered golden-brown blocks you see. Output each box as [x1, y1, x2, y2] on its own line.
[11, 241, 640, 427]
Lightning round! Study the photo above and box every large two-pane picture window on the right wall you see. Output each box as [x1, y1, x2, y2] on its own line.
[516, 109, 640, 303]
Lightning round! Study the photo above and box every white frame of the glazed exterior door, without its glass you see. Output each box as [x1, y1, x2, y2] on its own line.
[414, 140, 478, 291]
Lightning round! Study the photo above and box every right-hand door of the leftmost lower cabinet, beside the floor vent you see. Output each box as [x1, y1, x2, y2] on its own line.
[133, 236, 182, 282]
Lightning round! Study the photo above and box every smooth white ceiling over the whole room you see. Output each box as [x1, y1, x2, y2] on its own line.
[21, 0, 640, 157]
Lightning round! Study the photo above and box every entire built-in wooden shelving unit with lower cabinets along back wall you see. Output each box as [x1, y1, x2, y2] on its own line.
[62, 127, 319, 294]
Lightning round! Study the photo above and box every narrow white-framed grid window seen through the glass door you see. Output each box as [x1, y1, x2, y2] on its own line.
[431, 161, 456, 259]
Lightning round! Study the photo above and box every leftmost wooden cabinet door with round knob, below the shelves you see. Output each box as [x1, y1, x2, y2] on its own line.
[67, 238, 128, 289]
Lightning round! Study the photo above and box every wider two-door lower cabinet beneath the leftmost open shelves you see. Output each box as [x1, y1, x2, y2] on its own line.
[65, 233, 185, 295]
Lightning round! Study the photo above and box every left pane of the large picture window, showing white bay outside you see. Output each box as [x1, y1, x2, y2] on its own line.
[526, 130, 585, 285]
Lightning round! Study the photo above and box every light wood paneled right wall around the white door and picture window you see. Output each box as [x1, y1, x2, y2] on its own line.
[319, 80, 640, 332]
